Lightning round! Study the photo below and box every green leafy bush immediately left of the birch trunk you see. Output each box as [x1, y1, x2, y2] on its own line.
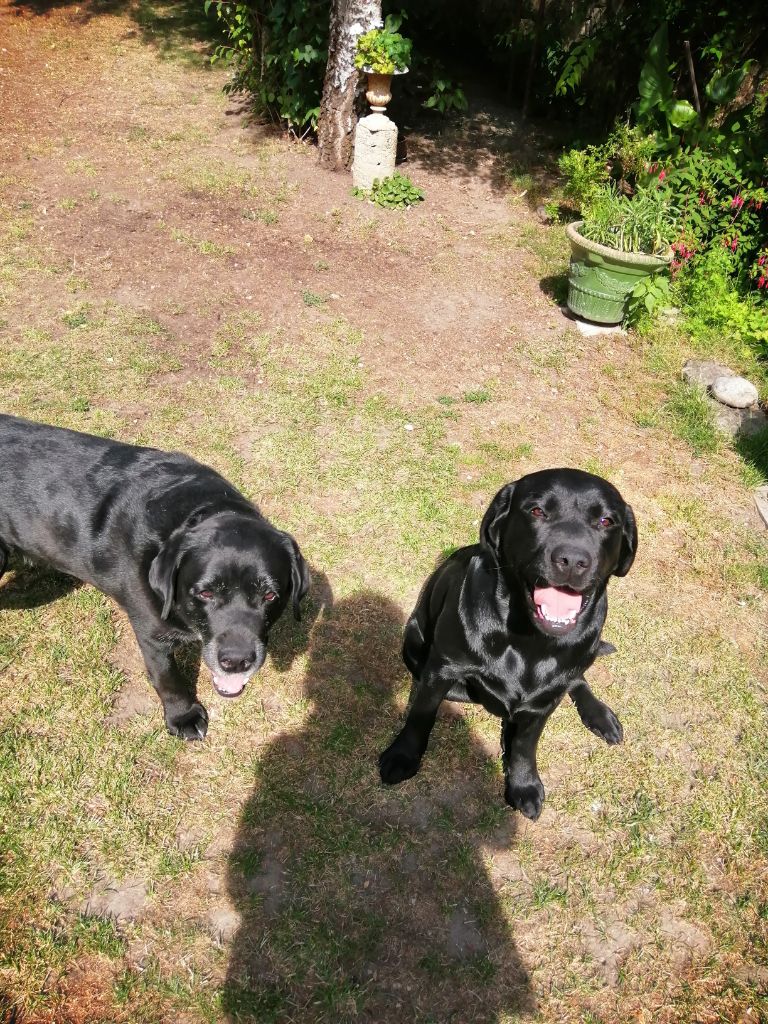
[205, 0, 329, 132]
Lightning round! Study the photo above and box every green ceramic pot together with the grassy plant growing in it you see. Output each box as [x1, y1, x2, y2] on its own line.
[565, 181, 679, 324]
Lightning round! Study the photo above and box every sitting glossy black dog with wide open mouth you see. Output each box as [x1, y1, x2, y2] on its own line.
[379, 469, 637, 819]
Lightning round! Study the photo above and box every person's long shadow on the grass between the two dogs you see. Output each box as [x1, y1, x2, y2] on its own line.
[222, 592, 535, 1024]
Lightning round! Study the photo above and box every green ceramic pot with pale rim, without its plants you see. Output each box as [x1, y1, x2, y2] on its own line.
[565, 220, 672, 324]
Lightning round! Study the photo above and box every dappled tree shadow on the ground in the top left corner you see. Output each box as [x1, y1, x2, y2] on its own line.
[12, 0, 223, 63]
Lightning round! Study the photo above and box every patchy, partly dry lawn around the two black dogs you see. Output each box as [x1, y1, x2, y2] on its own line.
[0, 0, 768, 1024]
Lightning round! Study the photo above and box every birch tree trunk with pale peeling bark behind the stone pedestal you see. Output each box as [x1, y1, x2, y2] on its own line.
[317, 0, 381, 171]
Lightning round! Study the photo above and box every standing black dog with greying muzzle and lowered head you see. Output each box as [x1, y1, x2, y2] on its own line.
[0, 416, 309, 739]
